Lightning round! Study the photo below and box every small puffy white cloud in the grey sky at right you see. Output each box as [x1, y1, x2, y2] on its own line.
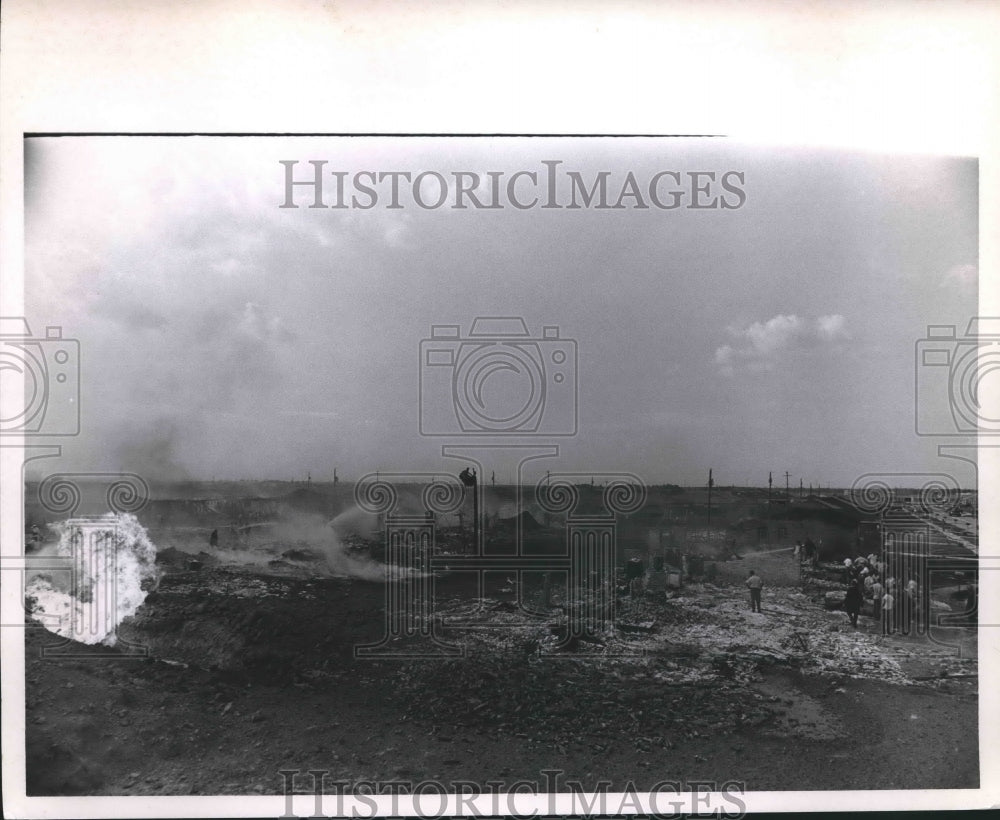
[715, 313, 850, 376]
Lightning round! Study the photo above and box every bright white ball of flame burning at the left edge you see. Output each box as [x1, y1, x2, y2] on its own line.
[25, 513, 158, 646]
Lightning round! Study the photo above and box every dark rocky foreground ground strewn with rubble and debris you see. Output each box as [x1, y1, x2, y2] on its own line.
[26, 552, 979, 795]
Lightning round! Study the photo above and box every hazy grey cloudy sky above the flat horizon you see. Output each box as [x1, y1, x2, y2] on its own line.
[19, 137, 978, 486]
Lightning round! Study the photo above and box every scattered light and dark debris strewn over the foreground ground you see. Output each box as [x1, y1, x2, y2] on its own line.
[384, 584, 975, 745]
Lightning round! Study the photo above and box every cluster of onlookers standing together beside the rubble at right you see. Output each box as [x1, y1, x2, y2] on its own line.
[844, 554, 920, 635]
